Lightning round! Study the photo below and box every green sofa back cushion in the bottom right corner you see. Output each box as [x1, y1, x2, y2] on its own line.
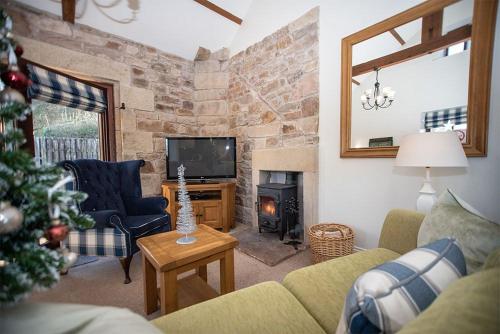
[399, 267, 500, 334]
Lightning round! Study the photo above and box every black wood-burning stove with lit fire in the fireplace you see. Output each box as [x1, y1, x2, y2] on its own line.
[256, 183, 298, 240]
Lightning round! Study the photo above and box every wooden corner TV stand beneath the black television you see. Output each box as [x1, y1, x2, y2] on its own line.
[161, 182, 236, 232]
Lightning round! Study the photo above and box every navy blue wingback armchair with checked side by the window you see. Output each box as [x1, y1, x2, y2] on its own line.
[60, 159, 171, 284]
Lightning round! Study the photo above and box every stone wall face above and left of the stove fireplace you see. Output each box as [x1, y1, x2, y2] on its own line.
[228, 8, 319, 224]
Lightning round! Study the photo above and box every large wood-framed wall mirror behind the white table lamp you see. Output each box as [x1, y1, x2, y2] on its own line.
[341, 0, 498, 158]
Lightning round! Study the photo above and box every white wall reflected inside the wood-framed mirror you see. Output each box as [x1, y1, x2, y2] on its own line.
[351, 50, 470, 147]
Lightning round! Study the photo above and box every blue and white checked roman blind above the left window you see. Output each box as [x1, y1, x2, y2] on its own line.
[27, 64, 108, 113]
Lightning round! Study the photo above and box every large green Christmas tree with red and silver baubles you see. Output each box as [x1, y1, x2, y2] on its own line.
[0, 10, 94, 305]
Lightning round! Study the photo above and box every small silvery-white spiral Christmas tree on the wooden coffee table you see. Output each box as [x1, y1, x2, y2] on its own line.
[176, 165, 196, 245]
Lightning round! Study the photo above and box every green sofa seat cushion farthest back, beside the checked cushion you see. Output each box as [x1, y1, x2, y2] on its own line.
[283, 248, 400, 333]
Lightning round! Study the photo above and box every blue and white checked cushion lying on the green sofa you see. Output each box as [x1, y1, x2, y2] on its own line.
[337, 238, 466, 333]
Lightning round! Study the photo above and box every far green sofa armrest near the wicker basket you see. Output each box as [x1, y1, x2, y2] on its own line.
[378, 209, 425, 254]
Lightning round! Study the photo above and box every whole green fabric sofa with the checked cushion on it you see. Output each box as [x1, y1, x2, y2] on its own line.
[152, 210, 500, 334]
